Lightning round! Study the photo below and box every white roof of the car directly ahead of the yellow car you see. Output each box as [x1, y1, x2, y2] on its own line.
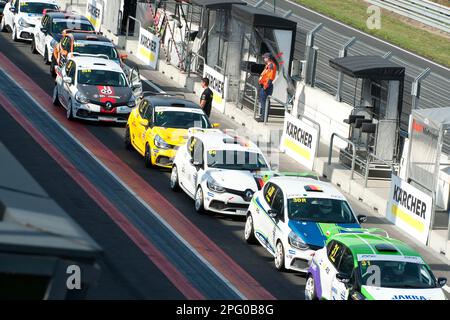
[190, 128, 262, 154]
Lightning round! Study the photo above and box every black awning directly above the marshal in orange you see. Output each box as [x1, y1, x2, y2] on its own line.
[233, 5, 297, 30]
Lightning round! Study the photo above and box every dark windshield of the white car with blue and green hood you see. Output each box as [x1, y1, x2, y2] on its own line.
[288, 197, 356, 223]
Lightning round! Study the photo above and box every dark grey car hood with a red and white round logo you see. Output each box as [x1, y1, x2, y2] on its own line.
[77, 84, 132, 107]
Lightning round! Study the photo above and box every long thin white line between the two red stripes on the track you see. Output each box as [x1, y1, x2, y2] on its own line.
[0, 68, 248, 300]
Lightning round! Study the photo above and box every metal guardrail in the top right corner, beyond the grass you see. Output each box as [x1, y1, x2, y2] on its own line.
[368, 0, 450, 33]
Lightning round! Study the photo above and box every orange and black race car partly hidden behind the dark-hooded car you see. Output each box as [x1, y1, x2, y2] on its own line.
[50, 29, 127, 76]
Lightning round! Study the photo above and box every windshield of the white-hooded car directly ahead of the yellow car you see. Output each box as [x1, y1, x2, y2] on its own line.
[207, 150, 268, 171]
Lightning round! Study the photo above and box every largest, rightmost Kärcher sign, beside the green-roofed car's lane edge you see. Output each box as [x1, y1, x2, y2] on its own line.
[386, 175, 433, 244]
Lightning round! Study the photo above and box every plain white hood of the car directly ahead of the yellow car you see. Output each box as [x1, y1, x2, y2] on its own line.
[208, 169, 258, 192]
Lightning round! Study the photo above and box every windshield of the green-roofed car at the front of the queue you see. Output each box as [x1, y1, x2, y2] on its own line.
[359, 260, 436, 289]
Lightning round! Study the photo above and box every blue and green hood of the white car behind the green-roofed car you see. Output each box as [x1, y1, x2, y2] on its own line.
[288, 220, 361, 248]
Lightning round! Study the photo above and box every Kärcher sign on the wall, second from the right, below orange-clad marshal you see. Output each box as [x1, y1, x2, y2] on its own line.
[280, 113, 319, 170]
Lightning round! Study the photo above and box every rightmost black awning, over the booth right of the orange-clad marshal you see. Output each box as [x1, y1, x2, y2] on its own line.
[330, 56, 405, 80]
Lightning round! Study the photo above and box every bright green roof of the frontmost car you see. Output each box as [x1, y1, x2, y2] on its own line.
[330, 232, 420, 258]
